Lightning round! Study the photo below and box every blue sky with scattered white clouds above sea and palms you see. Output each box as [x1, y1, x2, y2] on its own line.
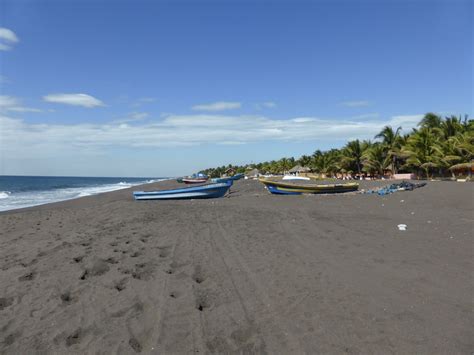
[0, 0, 474, 177]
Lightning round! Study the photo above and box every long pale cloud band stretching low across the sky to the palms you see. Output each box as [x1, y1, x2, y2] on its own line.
[0, 114, 422, 159]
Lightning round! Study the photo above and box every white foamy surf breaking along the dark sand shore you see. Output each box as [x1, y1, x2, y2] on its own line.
[0, 179, 166, 211]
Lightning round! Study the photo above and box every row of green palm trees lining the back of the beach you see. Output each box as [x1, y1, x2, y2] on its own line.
[203, 113, 474, 178]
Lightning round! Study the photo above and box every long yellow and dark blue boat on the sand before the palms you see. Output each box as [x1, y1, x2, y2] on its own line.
[259, 179, 359, 195]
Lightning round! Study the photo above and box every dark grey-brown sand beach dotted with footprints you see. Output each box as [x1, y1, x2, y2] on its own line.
[0, 181, 474, 354]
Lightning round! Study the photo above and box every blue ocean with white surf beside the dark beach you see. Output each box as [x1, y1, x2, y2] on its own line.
[0, 175, 167, 211]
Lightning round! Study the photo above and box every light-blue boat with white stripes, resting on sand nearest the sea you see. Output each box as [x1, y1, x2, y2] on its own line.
[133, 181, 232, 200]
